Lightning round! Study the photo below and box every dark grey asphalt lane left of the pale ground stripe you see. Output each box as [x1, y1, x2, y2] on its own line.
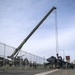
[0, 69, 50, 75]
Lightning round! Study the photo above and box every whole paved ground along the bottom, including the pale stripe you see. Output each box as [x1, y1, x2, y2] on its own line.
[0, 69, 75, 75]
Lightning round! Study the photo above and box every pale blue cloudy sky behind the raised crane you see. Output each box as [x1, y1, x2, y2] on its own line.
[0, 0, 75, 60]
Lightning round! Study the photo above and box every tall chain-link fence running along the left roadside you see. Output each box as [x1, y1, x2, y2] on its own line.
[0, 43, 47, 68]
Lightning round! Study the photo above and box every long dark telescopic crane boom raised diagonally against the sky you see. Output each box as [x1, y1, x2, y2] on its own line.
[9, 6, 56, 58]
